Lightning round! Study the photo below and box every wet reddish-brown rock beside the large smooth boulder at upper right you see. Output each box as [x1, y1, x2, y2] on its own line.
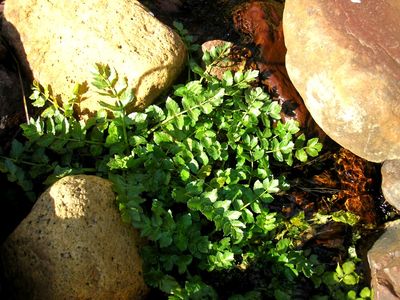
[233, 1, 324, 137]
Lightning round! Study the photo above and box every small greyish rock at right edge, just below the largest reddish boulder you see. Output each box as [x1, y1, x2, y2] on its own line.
[381, 160, 400, 211]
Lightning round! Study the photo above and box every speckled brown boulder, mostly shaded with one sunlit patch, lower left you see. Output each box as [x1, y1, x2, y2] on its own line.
[2, 175, 147, 299]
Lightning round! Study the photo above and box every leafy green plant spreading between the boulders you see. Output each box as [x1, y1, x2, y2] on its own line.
[0, 24, 370, 299]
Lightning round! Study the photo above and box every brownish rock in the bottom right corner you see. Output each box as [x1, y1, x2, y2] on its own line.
[368, 220, 400, 300]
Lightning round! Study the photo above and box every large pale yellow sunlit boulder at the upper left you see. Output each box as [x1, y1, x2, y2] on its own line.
[3, 0, 186, 114]
